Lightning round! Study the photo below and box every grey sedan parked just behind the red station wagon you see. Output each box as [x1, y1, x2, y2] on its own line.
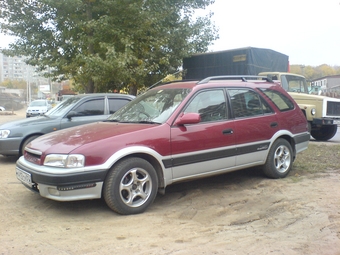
[0, 93, 135, 156]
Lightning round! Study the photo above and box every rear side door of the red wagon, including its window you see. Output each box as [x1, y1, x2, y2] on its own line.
[228, 88, 279, 166]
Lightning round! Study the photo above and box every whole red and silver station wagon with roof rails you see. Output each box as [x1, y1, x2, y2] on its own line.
[16, 76, 310, 214]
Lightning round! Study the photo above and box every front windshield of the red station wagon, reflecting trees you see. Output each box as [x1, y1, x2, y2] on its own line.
[106, 88, 190, 124]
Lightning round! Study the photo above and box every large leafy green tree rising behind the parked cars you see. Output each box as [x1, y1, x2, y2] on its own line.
[0, 0, 218, 94]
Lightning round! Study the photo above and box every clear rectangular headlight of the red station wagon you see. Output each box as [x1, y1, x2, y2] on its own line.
[44, 154, 85, 168]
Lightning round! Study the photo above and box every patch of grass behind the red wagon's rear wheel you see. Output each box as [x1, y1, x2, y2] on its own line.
[292, 143, 340, 176]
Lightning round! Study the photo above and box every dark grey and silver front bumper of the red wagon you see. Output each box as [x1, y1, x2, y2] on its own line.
[16, 157, 108, 201]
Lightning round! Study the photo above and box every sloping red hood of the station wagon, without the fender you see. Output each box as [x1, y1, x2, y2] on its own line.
[29, 122, 158, 154]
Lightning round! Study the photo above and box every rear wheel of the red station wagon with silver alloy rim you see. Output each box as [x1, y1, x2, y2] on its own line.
[263, 138, 293, 179]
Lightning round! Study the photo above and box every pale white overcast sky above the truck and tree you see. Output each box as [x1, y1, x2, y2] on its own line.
[0, 0, 340, 66]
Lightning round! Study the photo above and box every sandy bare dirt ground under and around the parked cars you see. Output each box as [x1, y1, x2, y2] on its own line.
[0, 108, 340, 255]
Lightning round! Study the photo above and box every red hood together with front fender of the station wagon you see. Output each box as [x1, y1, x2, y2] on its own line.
[30, 122, 170, 166]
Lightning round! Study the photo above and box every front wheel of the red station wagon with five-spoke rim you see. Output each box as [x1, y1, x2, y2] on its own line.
[103, 157, 158, 215]
